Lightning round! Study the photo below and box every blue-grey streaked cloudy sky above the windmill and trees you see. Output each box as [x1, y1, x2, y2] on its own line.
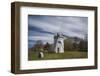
[28, 15, 88, 48]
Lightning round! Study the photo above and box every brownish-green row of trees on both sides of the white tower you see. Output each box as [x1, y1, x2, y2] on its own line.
[30, 37, 88, 52]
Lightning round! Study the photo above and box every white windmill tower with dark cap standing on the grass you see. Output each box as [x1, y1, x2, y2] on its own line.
[53, 18, 64, 53]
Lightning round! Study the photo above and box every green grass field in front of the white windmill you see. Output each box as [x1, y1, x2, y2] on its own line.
[28, 51, 88, 60]
